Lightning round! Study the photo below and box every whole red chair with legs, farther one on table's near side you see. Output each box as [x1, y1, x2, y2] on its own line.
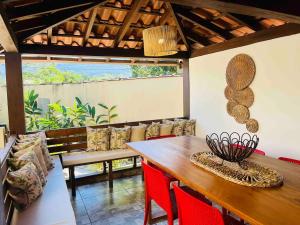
[142, 161, 212, 225]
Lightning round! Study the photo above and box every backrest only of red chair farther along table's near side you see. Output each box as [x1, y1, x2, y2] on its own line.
[142, 162, 172, 212]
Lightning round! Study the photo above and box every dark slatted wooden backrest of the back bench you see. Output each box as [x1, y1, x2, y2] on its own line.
[46, 118, 186, 154]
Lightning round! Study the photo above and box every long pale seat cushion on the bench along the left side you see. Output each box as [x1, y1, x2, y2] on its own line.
[11, 157, 76, 225]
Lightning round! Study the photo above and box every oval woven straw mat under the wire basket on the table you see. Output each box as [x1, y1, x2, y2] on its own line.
[190, 152, 283, 188]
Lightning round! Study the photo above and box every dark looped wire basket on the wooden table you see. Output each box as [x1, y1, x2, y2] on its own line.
[206, 132, 259, 166]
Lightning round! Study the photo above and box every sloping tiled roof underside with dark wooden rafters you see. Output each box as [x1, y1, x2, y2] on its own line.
[3, 0, 298, 57]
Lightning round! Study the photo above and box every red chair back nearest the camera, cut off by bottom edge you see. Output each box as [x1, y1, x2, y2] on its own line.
[174, 185, 224, 225]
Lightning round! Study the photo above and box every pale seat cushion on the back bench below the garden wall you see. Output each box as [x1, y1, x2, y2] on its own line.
[62, 149, 138, 167]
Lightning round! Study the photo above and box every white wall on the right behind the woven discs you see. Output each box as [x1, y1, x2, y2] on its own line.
[190, 34, 300, 159]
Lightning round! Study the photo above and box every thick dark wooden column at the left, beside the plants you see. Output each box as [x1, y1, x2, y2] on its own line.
[5, 53, 26, 134]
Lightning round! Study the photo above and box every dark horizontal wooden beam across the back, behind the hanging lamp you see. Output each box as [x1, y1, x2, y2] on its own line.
[20, 44, 189, 59]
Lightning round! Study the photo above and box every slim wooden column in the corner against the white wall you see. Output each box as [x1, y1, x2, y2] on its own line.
[182, 59, 190, 117]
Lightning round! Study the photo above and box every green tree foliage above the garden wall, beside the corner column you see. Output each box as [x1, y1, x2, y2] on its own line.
[131, 65, 177, 77]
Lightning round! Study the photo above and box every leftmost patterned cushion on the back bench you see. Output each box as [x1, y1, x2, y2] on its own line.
[86, 127, 110, 151]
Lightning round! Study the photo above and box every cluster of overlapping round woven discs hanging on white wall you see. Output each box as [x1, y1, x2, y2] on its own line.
[224, 54, 259, 133]
